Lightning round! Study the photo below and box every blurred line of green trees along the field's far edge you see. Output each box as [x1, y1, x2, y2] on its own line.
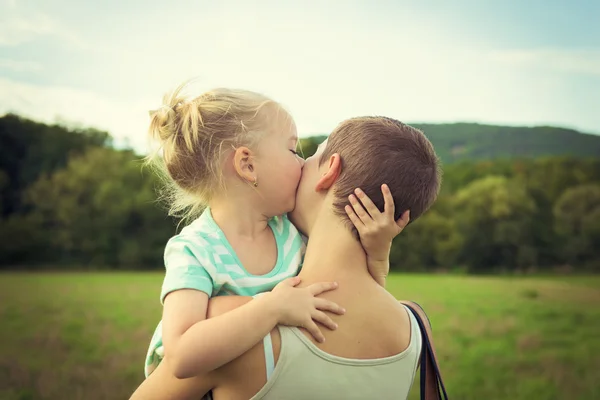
[0, 114, 600, 273]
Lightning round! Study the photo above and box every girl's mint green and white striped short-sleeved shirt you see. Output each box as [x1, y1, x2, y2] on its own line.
[144, 208, 306, 376]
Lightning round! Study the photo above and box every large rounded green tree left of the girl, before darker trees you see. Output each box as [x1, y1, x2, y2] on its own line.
[26, 147, 175, 268]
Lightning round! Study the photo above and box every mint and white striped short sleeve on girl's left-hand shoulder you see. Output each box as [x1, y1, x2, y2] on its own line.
[160, 236, 214, 304]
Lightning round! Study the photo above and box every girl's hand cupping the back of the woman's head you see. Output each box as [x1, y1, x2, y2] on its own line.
[345, 184, 410, 284]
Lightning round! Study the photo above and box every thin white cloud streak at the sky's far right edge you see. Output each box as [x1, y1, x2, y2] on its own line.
[490, 48, 600, 76]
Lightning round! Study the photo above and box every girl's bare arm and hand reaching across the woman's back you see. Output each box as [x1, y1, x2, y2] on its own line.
[163, 277, 344, 379]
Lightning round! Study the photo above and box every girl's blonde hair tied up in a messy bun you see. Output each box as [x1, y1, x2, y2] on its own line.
[146, 82, 282, 220]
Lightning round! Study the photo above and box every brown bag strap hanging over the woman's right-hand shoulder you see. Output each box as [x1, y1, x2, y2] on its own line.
[401, 301, 448, 400]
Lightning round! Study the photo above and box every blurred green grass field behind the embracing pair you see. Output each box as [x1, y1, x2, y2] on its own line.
[0, 273, 600, 400]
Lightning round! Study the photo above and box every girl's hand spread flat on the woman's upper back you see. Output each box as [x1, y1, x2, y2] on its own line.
[268, 277, 346, 342]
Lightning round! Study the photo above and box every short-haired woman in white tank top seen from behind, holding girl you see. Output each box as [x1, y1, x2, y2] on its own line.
[132, 117, 448, 400]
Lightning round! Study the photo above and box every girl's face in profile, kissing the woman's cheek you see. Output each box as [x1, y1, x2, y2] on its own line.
[255, 112, 304, 216]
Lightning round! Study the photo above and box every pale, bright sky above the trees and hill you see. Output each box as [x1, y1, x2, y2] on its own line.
[0, 0, 600, 149]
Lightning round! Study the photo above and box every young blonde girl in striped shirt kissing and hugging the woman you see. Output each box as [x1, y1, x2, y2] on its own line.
[145, 85, 406, 388]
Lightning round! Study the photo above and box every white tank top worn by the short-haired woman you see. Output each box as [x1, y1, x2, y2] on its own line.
[252, 306, 422, 400]
